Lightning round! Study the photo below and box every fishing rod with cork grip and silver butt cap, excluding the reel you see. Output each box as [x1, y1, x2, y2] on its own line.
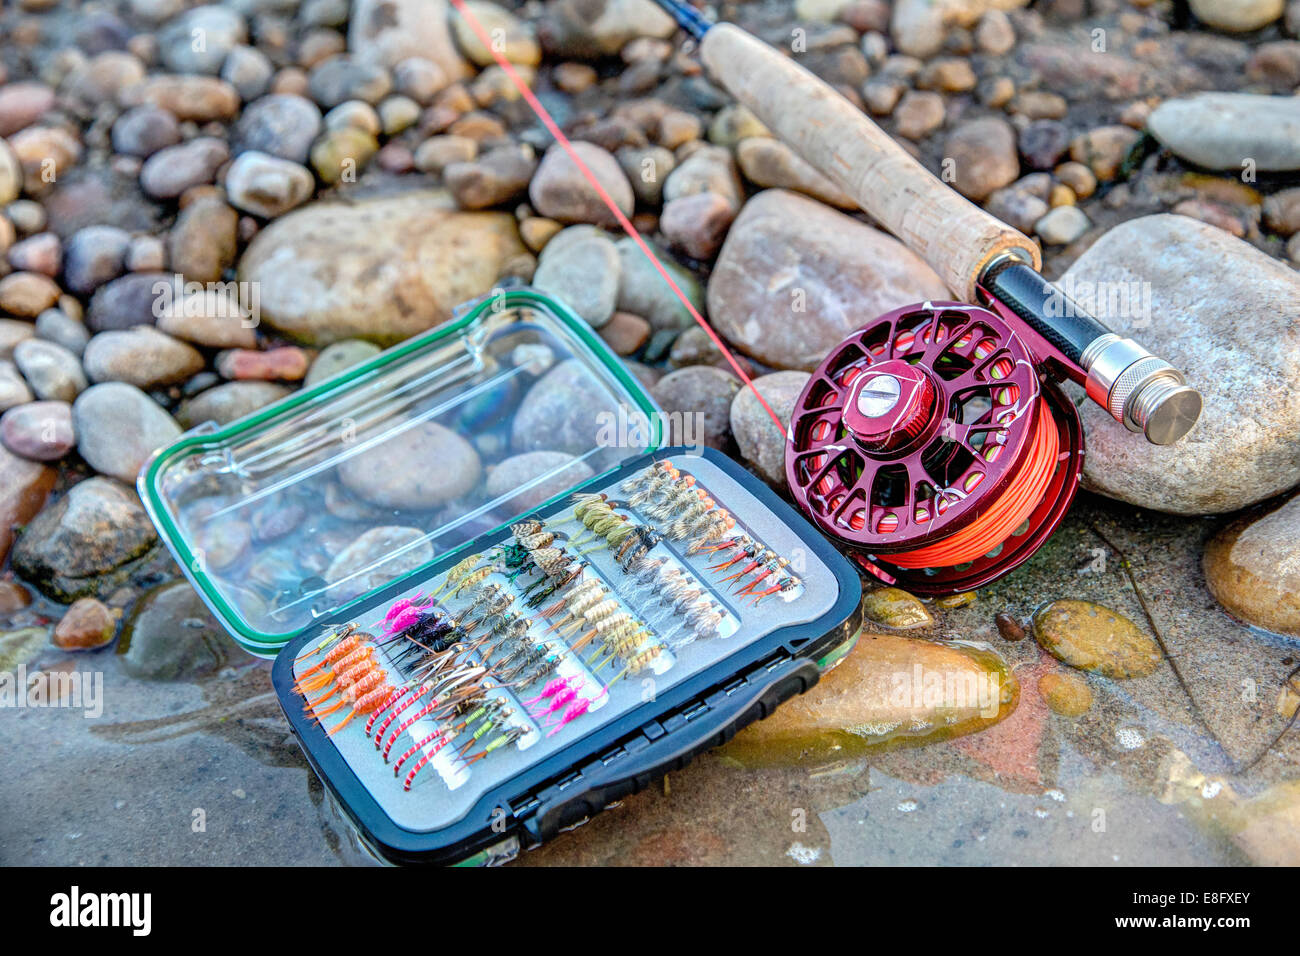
[655, 0, 1201, 445]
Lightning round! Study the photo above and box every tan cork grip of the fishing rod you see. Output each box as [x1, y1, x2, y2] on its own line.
[699, 23, 1043, 302]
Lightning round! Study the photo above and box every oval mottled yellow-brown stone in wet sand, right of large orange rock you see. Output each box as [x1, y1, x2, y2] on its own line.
[1034, 601, 1161, 680]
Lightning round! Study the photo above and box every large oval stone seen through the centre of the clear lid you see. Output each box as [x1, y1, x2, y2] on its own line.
[338, 421, 482, 509]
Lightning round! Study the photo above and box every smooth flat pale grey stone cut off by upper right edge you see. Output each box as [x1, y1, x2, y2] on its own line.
[1147, 92, 1300, 173]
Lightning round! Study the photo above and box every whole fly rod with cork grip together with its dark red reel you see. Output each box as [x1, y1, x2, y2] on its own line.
[644, 0, 1201, 594]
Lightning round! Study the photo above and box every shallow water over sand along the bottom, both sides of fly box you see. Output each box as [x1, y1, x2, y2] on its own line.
[0, 496, 1300, 866]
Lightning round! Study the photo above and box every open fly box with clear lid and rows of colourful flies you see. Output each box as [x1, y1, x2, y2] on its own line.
[139, 289, 861, 864]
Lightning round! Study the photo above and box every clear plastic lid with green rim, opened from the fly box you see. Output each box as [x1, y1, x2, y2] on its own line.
[138, 289, 660, 654]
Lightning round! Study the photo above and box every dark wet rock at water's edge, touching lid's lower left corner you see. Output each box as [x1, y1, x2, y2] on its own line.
[117, 580, 230, 682]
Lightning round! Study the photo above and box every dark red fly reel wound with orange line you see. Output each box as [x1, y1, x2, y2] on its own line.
[785, 302, 1084, 594]
